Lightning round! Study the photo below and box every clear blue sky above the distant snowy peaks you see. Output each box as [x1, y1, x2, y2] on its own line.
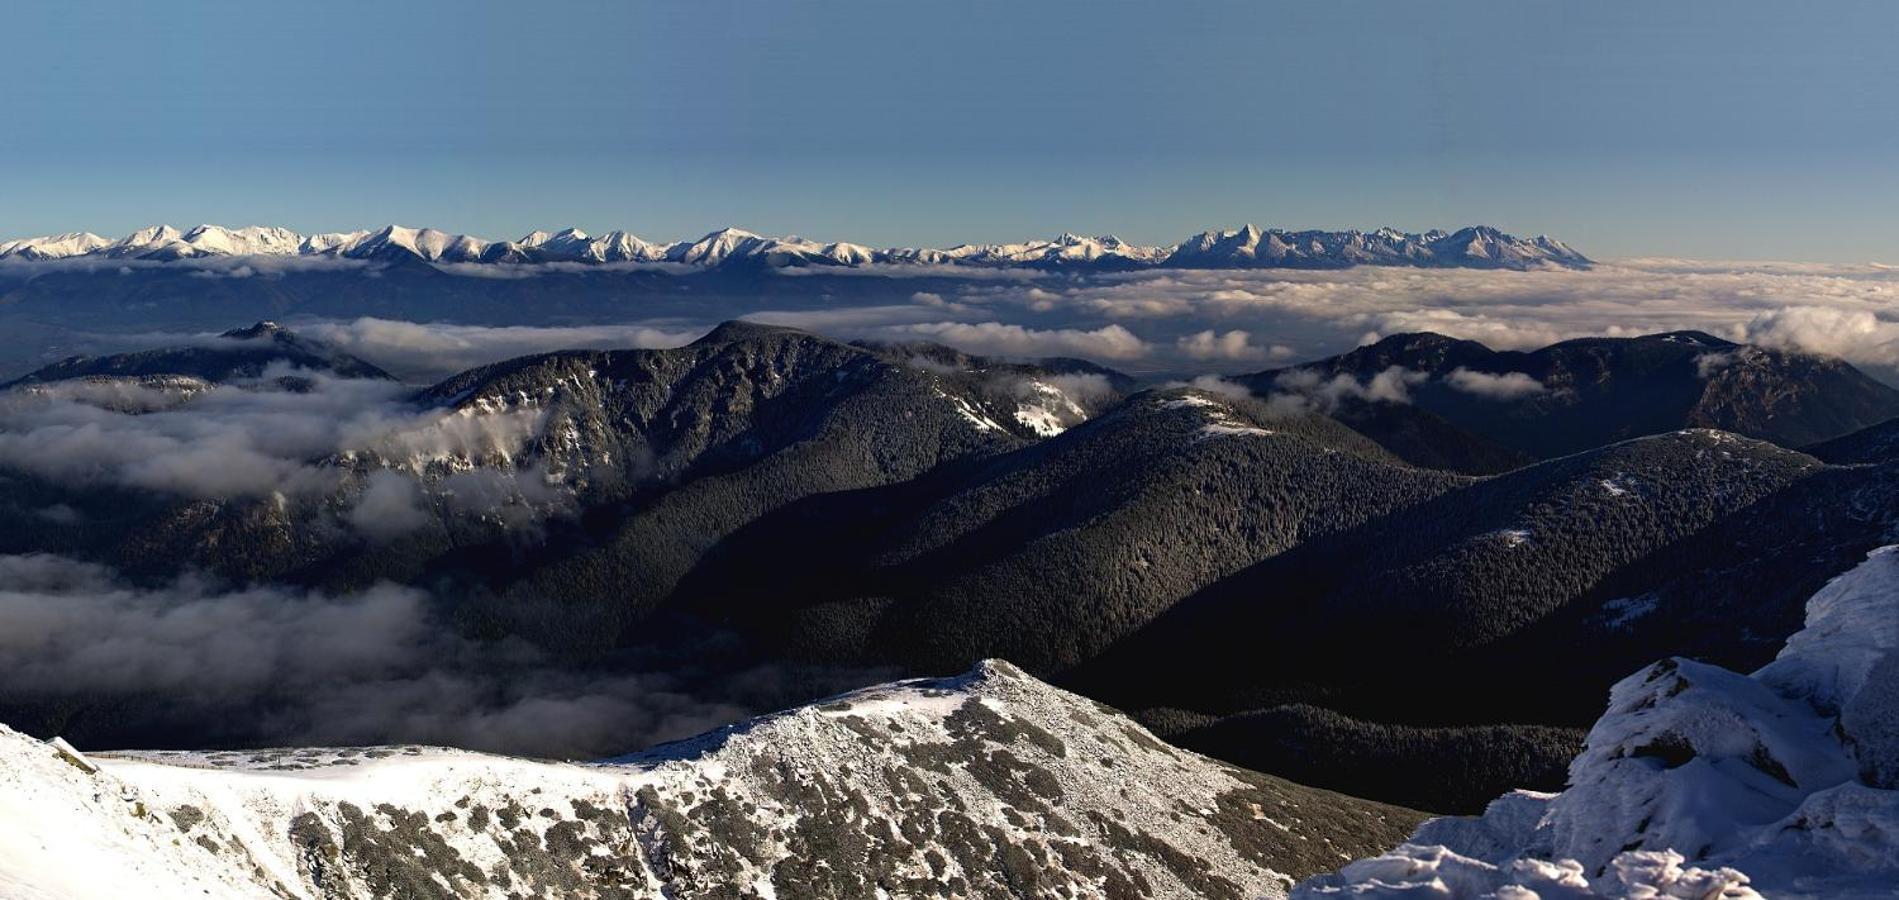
[0, 0, 1899, 262]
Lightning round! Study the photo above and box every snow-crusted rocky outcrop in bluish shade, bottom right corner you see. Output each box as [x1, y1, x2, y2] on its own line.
[1293, 547, 1899, 900]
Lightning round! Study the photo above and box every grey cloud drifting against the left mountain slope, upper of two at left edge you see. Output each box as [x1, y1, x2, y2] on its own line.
[0, 368, 566, 539]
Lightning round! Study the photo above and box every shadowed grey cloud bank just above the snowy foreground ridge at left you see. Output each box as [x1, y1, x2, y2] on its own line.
[0, 554, 889, 758]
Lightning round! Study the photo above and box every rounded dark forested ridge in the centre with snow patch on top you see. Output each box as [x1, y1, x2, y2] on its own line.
[672, 389, 1462, 672]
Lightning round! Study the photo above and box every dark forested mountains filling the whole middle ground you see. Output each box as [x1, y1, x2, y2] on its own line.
[0, 323, 1899, 809]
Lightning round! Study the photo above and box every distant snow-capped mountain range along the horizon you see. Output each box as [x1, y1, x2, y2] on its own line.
[0, 224, 1589, 272]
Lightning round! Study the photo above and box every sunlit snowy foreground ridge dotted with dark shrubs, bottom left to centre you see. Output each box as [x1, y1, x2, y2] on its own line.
[0, 663, 1420, 898]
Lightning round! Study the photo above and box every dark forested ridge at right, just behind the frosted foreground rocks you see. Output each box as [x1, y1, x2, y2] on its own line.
[1069, 431, 1833, 803]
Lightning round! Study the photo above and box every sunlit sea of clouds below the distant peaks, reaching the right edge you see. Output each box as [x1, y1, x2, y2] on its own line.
[733, 258, 1899, 378]
